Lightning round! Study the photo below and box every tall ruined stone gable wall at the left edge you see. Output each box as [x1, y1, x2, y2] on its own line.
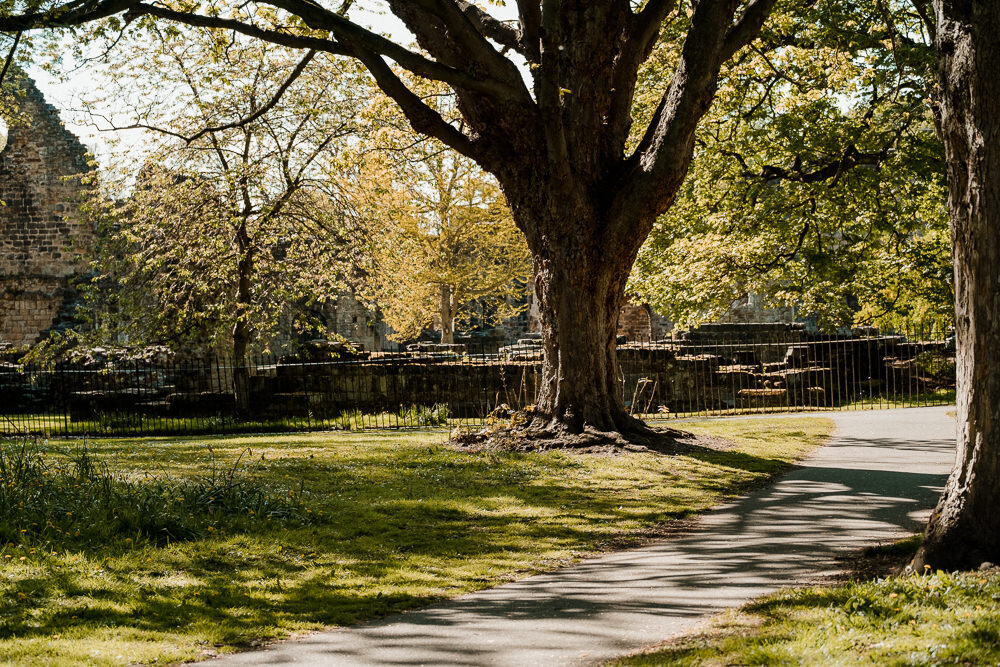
[0, 77, 91, 347]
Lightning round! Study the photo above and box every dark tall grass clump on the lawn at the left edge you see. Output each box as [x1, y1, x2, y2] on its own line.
[0, 439, 312, 548]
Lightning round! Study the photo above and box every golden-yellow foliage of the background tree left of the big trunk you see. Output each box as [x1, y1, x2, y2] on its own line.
[351, 82, 531, 342]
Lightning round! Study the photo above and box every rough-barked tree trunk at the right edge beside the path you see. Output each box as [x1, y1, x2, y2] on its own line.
[914, 0, 1000, 569]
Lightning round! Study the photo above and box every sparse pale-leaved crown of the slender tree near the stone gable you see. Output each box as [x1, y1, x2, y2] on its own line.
[77, 27, 364, 356]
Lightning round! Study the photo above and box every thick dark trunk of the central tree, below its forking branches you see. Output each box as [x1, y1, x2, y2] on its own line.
[515, 201, 651, 439]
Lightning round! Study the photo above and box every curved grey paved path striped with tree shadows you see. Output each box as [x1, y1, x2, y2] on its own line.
[213, 408, 955, 667]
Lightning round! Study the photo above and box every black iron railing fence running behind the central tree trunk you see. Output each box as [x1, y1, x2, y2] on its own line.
[0, 326, 955, 436]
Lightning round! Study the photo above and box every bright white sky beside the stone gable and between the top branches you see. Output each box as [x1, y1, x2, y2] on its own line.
[29, 0, 516, 162]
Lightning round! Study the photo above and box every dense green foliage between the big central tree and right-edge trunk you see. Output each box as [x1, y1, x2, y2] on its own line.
[629, 0, 952, 327]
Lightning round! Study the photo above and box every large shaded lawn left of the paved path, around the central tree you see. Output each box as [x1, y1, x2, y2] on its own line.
[0, 418, 832, 665]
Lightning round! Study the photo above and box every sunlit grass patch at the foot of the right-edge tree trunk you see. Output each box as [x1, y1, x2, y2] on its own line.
[610, 538, 1000, 667]
